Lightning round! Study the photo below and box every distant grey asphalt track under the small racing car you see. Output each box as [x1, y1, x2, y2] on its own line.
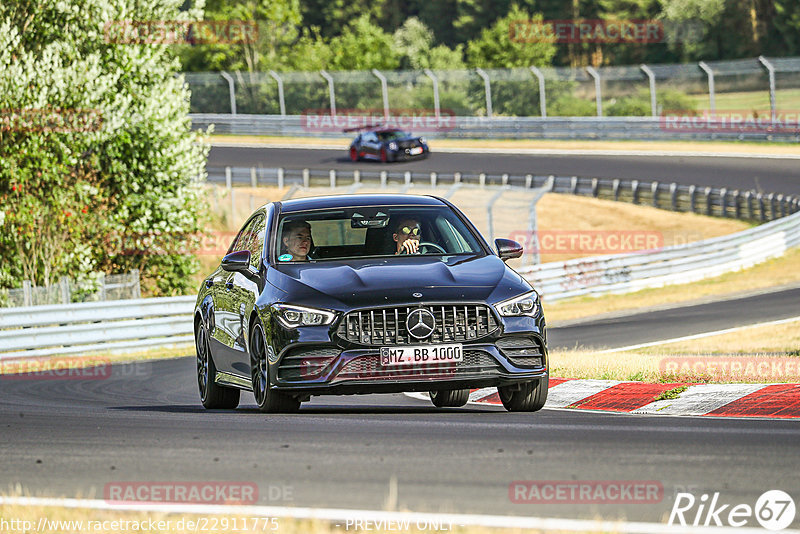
[208, 145, 800, 194]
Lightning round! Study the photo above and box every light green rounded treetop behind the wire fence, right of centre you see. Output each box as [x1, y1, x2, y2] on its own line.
[467, 5, 555, 68]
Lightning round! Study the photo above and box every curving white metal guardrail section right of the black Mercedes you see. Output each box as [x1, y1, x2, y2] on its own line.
[519, 209, 800, 302]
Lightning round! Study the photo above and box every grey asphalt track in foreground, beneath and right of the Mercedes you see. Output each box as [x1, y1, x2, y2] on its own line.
[0, 289, 800, 526]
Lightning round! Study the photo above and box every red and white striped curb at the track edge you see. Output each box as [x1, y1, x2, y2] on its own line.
[407, 378, 800, 419]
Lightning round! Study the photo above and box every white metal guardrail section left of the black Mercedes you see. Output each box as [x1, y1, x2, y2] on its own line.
[0, 296, 197, 360]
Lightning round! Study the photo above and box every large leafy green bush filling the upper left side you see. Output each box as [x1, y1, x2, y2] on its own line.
[0, 0, 207, 294]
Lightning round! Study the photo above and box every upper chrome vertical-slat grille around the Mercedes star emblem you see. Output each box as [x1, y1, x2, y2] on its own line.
[336, 305, 498, 346]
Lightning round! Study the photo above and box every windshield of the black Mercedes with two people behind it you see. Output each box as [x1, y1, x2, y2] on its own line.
[273, 206, 483, 263]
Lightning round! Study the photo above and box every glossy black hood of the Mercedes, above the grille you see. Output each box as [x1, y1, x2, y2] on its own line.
[267, 255, 530, 309]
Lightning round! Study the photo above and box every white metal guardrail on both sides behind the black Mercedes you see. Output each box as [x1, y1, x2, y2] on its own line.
[0, 213, 800, 360]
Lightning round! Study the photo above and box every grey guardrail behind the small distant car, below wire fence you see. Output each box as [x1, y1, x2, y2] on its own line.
[189, 113, 800, 143]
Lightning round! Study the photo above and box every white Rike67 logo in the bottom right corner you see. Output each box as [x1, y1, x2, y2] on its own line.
[669, 490, 795, 531]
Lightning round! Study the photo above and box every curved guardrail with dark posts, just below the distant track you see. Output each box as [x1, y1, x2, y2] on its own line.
[207, 167, 800, 222]
